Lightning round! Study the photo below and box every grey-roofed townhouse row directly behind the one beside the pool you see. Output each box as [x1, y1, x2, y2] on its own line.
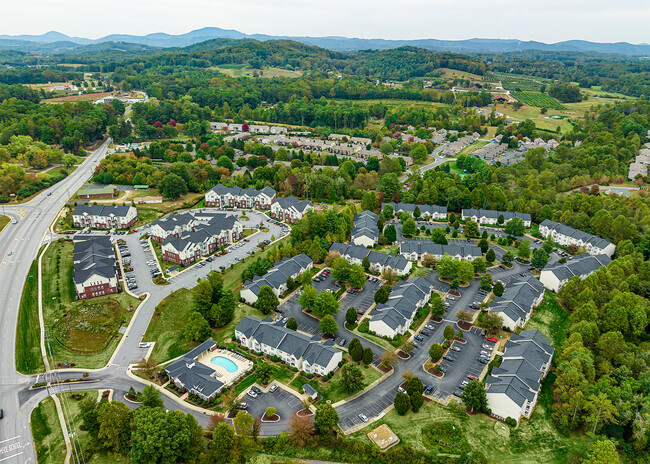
[239, 253, 314, 305]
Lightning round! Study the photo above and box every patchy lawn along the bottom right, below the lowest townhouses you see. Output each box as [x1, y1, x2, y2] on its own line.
[351, 401, 588, 464]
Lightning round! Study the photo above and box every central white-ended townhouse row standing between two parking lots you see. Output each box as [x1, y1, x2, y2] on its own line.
[369, 277, 433, 338]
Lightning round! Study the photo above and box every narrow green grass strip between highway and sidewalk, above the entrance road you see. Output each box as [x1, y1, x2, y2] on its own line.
[16, 249, 45, 375]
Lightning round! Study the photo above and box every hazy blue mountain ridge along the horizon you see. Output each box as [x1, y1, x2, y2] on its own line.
[0, 27, 650, 56]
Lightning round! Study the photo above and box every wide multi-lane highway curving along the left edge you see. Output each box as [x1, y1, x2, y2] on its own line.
[0, 139, 111, 464]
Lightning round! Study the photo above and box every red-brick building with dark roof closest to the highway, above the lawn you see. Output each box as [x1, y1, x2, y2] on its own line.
[72, 236, 119, 300]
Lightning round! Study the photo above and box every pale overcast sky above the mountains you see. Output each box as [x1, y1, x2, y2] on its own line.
[0, 0, 650, 43]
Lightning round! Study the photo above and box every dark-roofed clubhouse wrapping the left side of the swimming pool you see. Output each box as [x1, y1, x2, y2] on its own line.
[165, 338, 224, 401]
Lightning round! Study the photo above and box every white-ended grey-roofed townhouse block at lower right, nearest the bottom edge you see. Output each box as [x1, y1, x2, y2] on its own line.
[485, 330, 555, 422]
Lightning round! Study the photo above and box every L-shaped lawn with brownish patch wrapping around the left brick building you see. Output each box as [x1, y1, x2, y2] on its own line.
[42, 241, 139, 369]
